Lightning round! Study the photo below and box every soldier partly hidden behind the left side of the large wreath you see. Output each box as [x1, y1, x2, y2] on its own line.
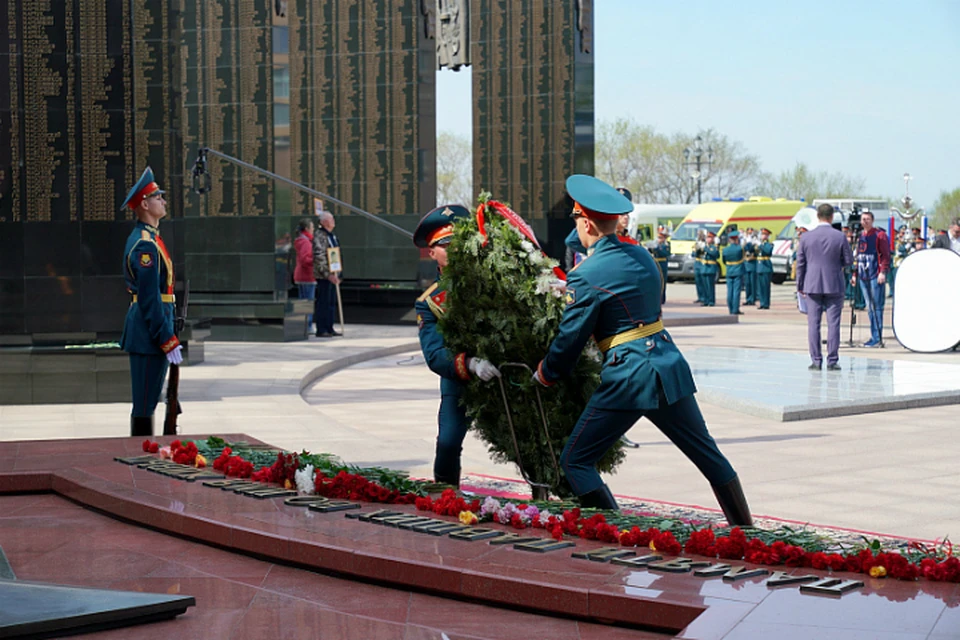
[413, 204, 500, 487]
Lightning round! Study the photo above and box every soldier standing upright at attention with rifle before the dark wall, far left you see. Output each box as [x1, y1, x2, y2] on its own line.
[120, 167, 183, 436]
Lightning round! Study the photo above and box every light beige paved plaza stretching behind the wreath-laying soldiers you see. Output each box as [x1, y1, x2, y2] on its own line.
[0, 283, 960, 539]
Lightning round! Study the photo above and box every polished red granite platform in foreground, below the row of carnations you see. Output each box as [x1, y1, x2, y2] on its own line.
[0, 435, 960, 640]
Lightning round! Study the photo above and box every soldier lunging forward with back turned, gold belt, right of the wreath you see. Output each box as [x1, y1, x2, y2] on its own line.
[533, 175, 752, 526]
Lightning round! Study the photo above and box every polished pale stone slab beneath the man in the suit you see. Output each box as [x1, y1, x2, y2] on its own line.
[684, 347, 960, 422]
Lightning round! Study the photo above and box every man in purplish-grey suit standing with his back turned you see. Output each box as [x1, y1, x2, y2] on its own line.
[797, 204, 853, 371]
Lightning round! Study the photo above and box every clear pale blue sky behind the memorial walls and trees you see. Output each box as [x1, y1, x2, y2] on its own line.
[437, 0, 960, 208]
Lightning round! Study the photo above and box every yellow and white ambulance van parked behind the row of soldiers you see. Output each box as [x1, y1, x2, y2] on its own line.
[667, 196, 805, 281]
